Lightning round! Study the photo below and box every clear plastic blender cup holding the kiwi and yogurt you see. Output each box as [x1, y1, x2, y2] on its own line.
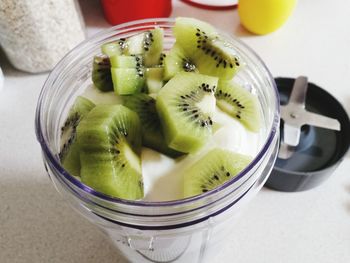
[36, 19, 279, 262]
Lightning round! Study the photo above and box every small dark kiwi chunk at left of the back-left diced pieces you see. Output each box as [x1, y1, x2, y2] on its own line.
[92, 56, 113, 91]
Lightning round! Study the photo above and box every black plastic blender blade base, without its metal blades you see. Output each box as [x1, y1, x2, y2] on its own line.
[265, 78, 350, 192]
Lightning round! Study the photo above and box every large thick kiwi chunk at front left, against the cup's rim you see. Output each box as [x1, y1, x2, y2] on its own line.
[77, 105, 143, 200]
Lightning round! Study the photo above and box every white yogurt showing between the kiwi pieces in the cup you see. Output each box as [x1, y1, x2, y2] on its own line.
[82, 87, 262, 201]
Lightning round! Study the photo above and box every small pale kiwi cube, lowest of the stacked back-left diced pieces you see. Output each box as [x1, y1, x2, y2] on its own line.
[111, 68, 145, 95]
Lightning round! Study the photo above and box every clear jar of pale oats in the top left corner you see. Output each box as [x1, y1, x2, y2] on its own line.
[0, 0, 85, 73]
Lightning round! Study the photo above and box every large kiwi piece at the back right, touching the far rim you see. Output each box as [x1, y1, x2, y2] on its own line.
[165, 17, 241, 79]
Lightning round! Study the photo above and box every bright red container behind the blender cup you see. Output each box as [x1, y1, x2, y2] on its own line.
[101, 0, 172, 25]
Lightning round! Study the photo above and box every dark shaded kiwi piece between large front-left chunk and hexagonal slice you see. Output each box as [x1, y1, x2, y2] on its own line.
[123, 94, 182, 158]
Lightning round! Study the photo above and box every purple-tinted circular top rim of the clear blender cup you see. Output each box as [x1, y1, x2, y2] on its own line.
[35, 18, 280, 207]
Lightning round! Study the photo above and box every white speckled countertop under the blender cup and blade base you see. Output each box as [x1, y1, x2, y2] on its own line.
[0, 0, 350, 263]
